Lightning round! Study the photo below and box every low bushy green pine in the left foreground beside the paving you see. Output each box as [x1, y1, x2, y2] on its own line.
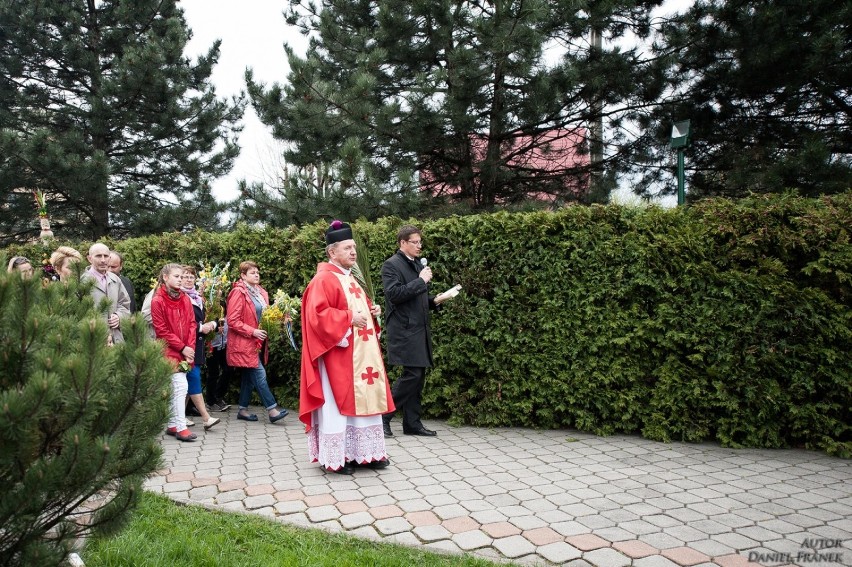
[0, 271, 171, 565]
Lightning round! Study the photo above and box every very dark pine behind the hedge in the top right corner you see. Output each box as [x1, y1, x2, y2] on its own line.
[640, 0, 852, 198]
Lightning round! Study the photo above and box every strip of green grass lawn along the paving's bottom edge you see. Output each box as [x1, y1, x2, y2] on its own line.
[81, 492, 505, 567]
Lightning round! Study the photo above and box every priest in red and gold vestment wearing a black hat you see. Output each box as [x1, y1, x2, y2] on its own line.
[299, 221, 396, 474]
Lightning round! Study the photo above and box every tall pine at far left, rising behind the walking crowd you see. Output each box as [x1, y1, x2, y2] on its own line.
[0, 0, 245, 240]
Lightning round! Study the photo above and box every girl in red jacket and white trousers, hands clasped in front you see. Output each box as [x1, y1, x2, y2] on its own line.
[151, 264, 196, 441]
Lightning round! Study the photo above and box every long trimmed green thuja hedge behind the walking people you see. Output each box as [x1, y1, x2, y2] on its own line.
[8, 193, 852, 457]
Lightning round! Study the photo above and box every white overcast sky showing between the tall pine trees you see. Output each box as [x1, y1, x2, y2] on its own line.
[179, 0, 694, 204]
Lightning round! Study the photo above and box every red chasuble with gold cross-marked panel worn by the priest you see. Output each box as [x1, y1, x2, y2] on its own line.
[299, 262, 395, 431]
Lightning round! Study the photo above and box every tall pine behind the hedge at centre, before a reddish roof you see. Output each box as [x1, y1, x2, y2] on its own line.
[247, 0, 661, 211]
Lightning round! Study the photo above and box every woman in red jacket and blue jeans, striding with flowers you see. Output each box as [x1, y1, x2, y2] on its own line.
[226, 262, 287, 423]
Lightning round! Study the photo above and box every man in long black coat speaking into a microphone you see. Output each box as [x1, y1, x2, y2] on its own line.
[382, 225, 438, 437]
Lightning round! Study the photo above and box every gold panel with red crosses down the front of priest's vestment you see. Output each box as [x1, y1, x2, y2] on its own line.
[333, 272, 388, 415]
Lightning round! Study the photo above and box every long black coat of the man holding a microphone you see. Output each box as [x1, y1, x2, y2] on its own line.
[382, 251, 438, 368]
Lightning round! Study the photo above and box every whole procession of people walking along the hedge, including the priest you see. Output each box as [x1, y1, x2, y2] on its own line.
[8, 221, 440, 474]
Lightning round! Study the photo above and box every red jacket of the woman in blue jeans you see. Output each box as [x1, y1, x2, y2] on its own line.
[225, 280, 269, 368]
